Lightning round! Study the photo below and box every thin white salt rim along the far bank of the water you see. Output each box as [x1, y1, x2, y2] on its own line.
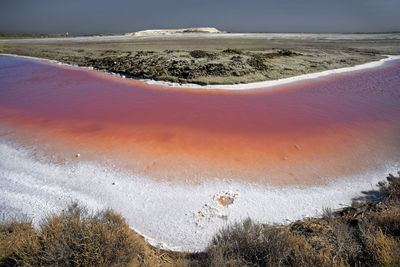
[0, 53, 400, 91]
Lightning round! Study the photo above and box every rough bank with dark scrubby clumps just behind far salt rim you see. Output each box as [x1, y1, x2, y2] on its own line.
[83, 49, 379, 84]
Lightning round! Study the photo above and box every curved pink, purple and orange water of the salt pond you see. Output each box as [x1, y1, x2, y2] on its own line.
[0, 57, 400, 184]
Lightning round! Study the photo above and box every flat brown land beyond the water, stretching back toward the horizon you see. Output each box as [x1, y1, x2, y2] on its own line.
[0, 34, 400, 85]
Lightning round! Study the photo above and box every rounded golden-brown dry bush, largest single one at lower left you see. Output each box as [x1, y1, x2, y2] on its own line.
[38, 205, 146, 266]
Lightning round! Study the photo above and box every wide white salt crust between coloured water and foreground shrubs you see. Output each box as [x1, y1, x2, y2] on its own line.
[0, 137, 399, 251]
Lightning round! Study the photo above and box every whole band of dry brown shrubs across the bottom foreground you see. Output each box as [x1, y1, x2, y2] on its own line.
[0, 172, 400, 266]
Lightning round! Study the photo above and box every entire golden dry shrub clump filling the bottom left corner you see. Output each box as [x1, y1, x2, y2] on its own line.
[0, 204, 186, 266]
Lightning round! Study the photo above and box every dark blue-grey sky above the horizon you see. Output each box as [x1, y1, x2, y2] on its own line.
[0, 0, 400, 34]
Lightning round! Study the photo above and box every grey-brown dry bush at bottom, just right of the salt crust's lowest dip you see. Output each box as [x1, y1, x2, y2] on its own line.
[206, 219, 323, 266]
